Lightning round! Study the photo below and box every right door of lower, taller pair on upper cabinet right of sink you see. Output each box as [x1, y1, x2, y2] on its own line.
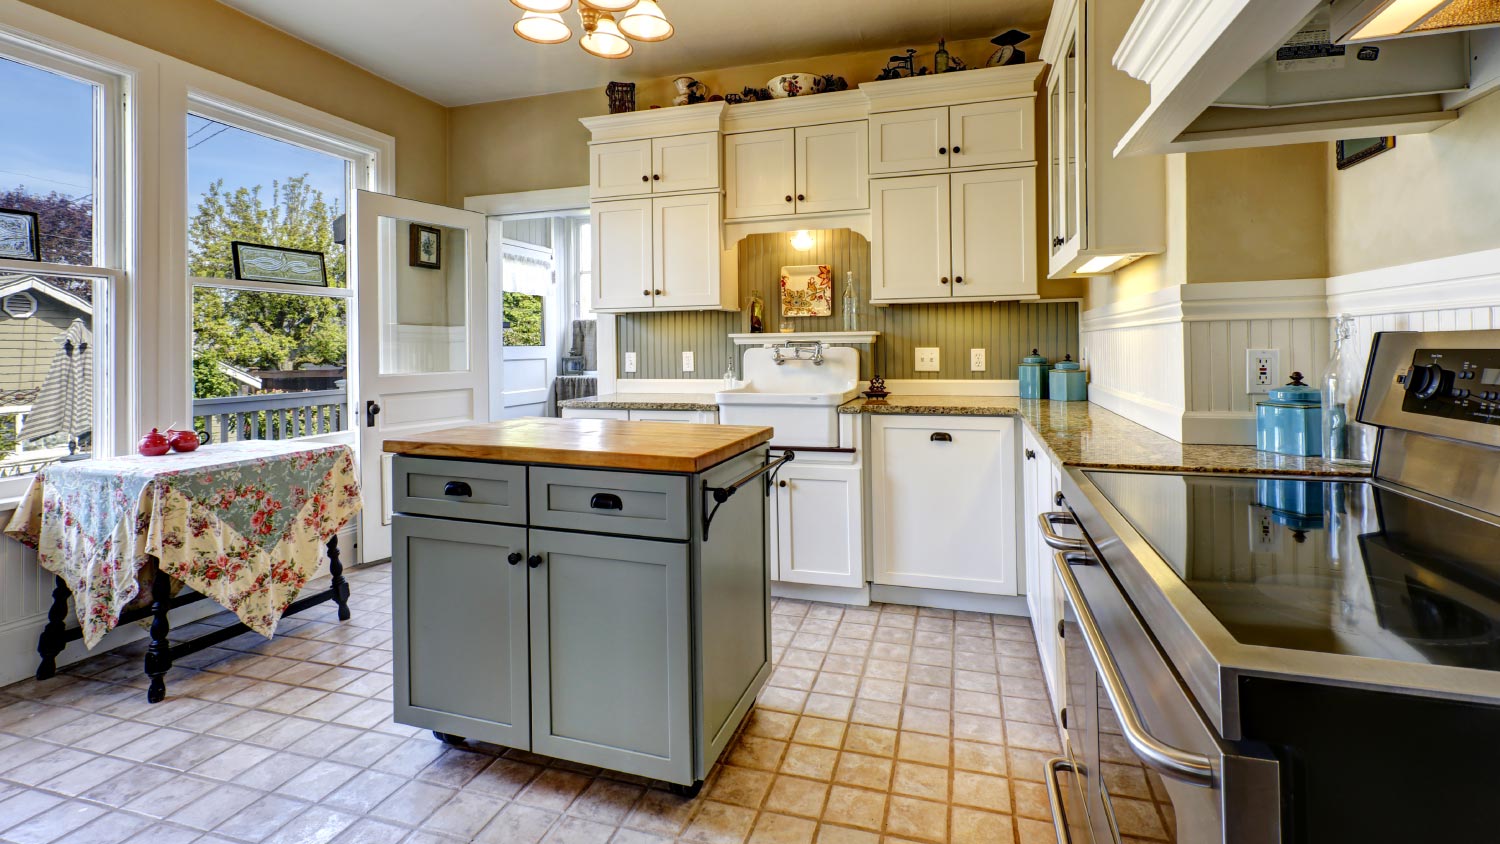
[950, 166, 1037, 298]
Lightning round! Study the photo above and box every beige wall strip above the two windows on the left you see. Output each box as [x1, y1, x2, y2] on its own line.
[26, 0, 447, 202]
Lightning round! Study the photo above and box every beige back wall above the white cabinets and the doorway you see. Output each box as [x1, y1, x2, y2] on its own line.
[449, 33, 1014, 205]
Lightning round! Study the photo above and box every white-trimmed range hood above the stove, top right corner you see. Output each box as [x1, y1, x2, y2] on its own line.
[1115, 0, 1500, 156]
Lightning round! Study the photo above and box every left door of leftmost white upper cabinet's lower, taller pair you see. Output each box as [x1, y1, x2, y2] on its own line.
[590, 199, 653, 310]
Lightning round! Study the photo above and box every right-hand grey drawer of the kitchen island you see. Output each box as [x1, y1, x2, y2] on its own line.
[531, 466, 692, 540]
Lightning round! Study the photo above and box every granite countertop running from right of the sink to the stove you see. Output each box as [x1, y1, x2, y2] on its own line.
[839, 396, 1370, 477]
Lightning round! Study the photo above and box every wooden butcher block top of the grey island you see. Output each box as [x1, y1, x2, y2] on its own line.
[384, 417, 771, 472]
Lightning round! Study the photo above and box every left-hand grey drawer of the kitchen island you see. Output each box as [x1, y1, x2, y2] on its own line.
[392, 456, 527, 525]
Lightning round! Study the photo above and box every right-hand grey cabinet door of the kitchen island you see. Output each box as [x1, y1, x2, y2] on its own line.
[528, 529, 693, 784]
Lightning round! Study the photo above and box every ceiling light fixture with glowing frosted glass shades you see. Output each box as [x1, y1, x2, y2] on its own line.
[510, 0, 675, 58]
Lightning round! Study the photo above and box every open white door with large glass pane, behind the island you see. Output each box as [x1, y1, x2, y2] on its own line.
[353, 190, 495, 561]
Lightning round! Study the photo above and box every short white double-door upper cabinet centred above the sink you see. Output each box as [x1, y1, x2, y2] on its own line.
[725, 120, 870, 220]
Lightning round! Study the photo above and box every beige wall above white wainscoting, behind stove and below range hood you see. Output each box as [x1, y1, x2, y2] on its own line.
[1325, 89, 1500, 276]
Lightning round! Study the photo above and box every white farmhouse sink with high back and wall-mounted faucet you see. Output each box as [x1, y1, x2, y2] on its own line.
[714, 346, 860, 447]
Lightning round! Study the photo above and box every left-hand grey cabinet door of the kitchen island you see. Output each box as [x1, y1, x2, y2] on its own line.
[392, 514, 531, 750]
